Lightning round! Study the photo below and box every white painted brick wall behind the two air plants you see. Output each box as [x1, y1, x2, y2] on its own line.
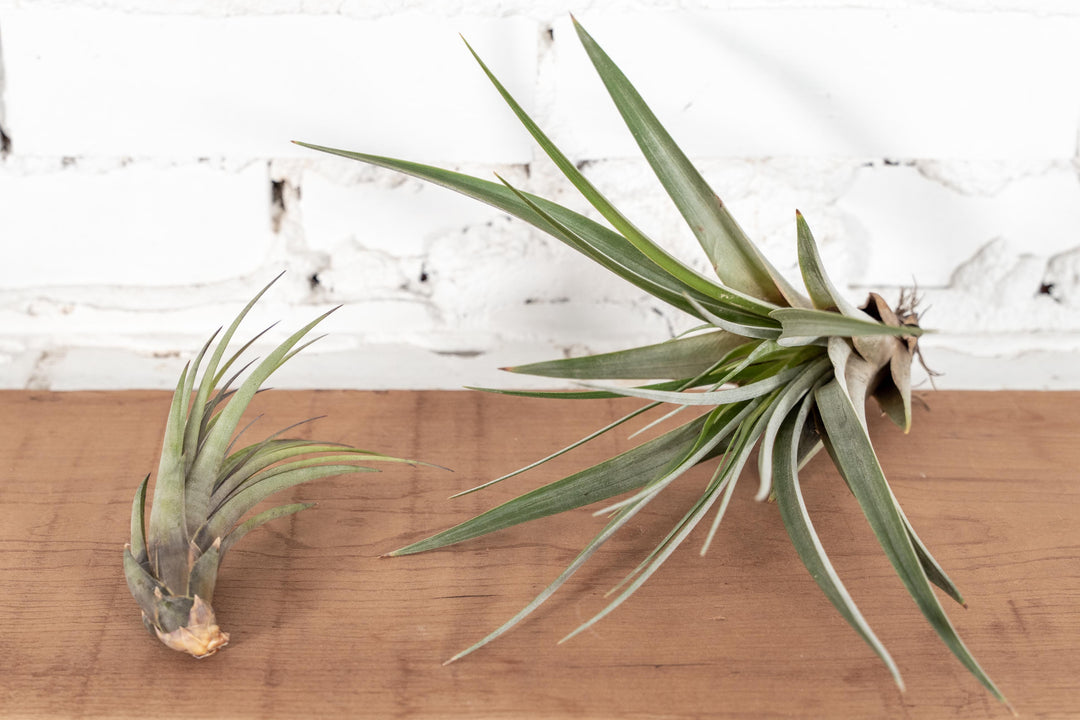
[0, 0, 1080, 390]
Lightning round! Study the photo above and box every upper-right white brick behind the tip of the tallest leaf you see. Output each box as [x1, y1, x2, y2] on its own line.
[552, 6, 1080, 158]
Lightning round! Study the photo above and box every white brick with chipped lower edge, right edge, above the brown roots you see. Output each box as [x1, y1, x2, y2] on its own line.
[838, 164, 1080, 293]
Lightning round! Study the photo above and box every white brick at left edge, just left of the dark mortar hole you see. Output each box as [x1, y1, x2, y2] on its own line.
[0, 162, 274, 289]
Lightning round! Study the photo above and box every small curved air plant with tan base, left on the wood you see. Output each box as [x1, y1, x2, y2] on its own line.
[124, 275, 413, 657]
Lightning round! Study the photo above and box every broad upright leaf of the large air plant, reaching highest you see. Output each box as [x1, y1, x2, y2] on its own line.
[573, 21, 806, 305]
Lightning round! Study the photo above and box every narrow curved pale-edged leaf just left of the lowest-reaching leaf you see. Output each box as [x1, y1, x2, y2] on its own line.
[772, 395, 904, 691]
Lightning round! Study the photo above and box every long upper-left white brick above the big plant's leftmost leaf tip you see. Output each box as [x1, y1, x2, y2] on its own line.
[0, 8, 538, 162]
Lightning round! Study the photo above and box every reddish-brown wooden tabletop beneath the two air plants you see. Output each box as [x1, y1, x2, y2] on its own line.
[0, 391, 1080, 718]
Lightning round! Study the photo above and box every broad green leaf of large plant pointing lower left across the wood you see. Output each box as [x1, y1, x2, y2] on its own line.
[391, 410, 705, 555]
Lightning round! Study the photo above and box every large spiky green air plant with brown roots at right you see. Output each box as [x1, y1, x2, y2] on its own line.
[293, 21, 1004, 702]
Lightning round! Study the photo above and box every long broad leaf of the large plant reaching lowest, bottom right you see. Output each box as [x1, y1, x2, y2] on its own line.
[814, 379, 1008, 705]
